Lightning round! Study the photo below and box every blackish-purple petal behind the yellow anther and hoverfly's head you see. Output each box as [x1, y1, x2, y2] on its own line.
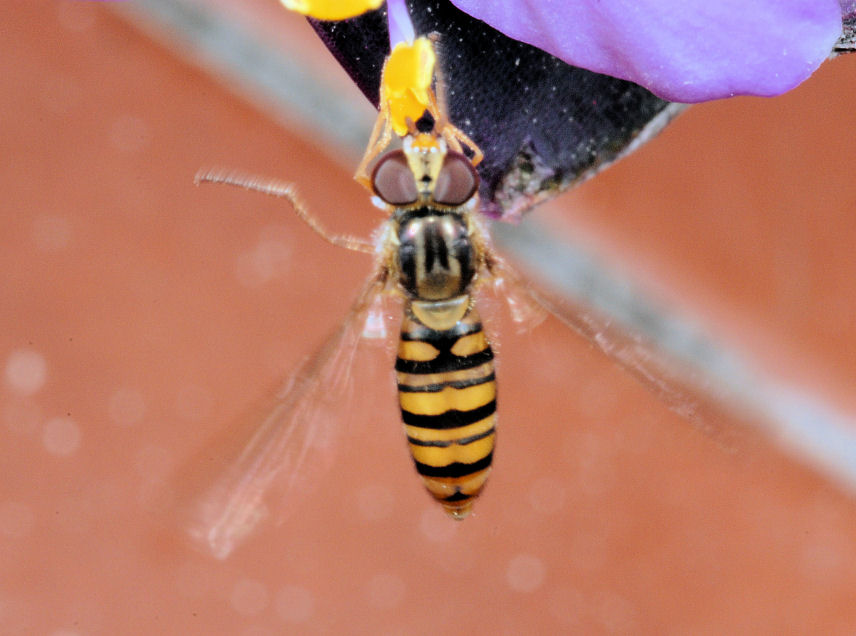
[311, 0, 677, 220]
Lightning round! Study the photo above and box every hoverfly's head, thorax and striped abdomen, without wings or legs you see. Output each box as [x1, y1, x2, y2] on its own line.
[372, 135, 496, 519]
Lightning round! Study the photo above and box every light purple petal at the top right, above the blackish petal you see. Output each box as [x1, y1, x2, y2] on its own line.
[452, 0, 848, 102]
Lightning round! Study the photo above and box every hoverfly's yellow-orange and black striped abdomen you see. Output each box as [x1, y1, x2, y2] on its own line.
[395, 308, 496, 519]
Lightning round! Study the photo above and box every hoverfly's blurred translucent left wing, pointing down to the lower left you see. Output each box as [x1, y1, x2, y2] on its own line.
[187, 278, 392, 559]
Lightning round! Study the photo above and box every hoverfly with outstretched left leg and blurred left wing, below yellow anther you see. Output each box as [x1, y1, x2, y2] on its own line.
[191, 36, 540, 557]
